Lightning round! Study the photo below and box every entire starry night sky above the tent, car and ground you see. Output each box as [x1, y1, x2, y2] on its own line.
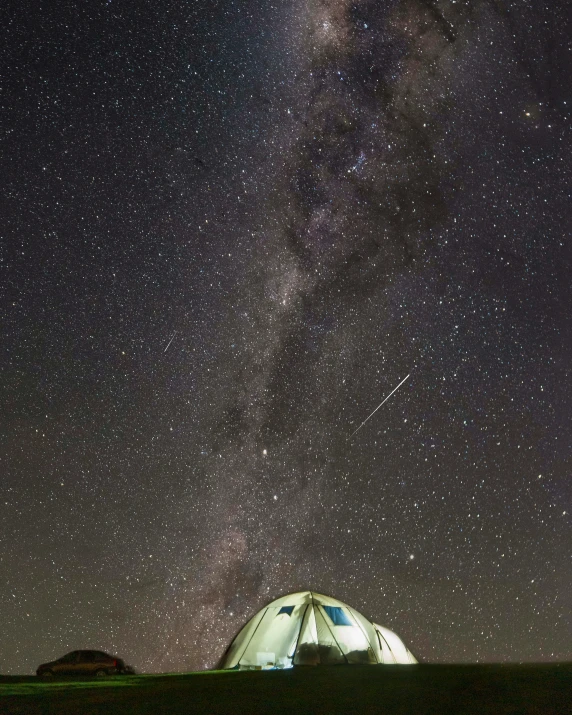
[0, 0, 572, 673]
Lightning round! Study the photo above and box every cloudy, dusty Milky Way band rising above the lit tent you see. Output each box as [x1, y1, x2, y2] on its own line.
[165, 2, 572, 672]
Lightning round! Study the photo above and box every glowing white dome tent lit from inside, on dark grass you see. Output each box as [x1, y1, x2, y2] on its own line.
[219, 591, 417, 670]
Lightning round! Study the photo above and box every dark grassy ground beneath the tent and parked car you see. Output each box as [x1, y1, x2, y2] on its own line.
[0, 664, 572, 715]
